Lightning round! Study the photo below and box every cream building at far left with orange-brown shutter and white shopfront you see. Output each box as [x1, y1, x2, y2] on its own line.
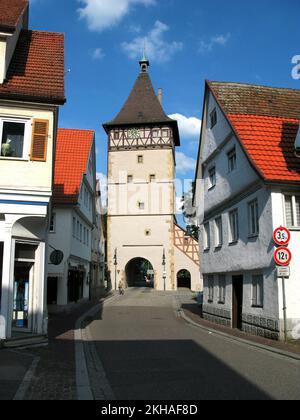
[0, 0, 65, 340]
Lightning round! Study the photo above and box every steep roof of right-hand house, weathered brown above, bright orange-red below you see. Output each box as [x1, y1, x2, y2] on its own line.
[208, 82, 300, 182]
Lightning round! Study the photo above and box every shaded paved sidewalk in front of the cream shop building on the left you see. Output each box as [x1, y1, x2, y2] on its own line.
[0, 294, 112, 400]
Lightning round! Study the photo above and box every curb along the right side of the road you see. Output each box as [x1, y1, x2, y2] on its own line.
[176, 301, 300, 362]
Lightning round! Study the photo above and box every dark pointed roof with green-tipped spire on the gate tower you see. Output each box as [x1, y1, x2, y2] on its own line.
[103, 61, 180, 146]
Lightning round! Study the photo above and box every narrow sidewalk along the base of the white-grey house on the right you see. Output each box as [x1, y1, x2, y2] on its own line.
[181, 300, 300, 356]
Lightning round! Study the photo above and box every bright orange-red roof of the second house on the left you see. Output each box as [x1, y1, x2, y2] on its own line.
[53, 128, 95, 205]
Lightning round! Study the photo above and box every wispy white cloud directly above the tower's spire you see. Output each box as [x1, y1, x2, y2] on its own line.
[122, 20, 183, 63]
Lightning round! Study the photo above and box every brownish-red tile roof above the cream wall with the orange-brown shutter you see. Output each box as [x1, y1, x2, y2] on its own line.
[0, 29, 65, 104]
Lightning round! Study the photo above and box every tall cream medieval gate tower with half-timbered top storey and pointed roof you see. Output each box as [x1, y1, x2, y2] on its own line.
[104, 56, 201, 290]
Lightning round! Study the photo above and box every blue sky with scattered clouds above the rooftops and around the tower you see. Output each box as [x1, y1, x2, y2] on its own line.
[30, 0, 300, 217]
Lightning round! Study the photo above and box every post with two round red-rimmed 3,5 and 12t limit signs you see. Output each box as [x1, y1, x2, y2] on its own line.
[273, 227, 292, 342]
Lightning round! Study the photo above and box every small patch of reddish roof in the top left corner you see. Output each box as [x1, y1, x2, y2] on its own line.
[0, 0, 28, 32]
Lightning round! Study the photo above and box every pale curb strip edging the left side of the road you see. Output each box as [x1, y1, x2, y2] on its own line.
[74, 295, 115, 401]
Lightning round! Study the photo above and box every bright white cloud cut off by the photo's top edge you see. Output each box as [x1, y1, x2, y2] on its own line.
[78, 0, 156, 32]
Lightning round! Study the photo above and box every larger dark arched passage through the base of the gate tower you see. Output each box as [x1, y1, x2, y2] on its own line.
[125, 258, 154, 287]
